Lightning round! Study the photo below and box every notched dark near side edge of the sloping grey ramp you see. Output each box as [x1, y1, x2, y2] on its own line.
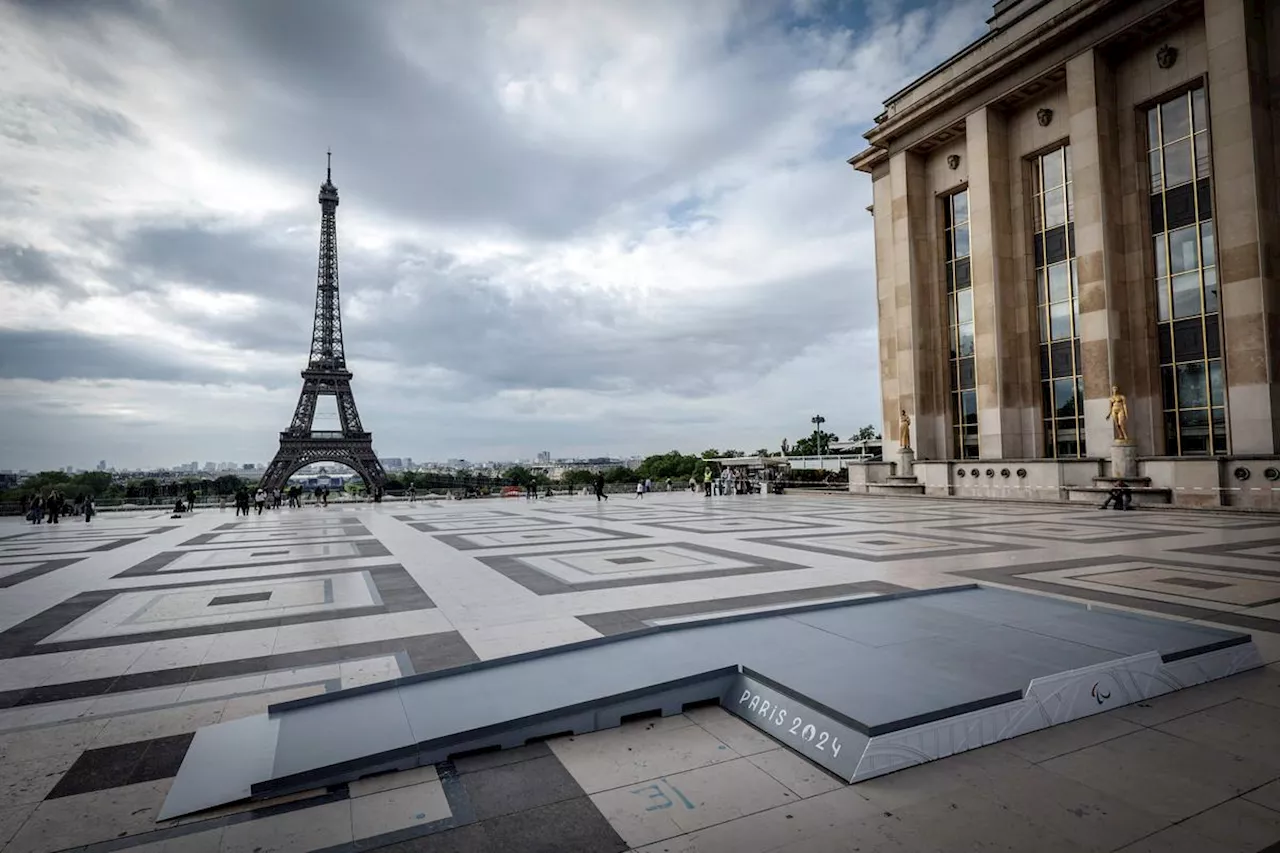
[250, 666, 740, 799]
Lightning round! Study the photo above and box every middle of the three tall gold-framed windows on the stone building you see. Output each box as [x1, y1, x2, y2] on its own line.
[1032, 145, 1084, 457]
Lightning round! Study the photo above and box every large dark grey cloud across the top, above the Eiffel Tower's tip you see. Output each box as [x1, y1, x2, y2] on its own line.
[20, 0, 803, 240]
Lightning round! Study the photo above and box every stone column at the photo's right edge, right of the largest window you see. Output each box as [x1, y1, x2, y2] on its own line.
[1204, 0, 1280, 453]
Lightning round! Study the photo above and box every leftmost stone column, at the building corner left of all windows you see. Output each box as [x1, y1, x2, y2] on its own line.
[879, 151, 948, 459]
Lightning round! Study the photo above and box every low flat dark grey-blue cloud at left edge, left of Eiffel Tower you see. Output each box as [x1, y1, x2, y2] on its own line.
[0, 329, 217, 383]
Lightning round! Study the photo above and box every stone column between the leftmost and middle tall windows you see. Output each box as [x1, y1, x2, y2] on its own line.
[965, 108, 1034, 459]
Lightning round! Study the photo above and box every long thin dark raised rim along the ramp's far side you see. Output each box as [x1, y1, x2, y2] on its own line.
[266, 584, 983, 715]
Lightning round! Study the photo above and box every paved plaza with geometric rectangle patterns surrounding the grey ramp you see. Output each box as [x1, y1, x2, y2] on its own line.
[0, 492, 1280, 853]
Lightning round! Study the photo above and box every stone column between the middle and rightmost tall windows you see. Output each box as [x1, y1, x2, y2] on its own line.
[1066, 50, 1136, 459]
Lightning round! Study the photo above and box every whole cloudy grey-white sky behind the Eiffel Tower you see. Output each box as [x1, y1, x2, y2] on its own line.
[0, 0, 991, 470]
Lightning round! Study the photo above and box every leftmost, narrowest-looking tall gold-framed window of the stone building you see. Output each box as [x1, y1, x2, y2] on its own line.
[943, 190, 978, 459]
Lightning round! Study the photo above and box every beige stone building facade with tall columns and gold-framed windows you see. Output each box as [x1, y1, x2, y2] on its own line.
[849, 0, 1280, 508]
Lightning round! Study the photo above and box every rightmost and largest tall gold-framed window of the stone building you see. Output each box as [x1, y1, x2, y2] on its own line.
[1147, 87, 1228, 456]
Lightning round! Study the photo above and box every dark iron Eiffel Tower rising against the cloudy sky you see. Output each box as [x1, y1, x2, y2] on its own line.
[261, 152, 387, 489]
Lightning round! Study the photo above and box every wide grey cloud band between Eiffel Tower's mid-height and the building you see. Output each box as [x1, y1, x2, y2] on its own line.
[346, 258, 852, 397]
